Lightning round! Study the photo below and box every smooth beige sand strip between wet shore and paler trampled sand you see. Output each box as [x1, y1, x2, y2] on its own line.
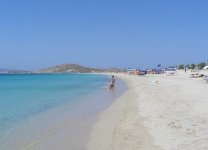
[87, 74, 160, 150]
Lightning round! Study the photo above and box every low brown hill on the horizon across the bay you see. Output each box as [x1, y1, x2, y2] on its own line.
[34, 64, 121, 73]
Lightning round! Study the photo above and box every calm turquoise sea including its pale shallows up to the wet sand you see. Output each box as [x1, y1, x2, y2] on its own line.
[0, 74, 125, 150]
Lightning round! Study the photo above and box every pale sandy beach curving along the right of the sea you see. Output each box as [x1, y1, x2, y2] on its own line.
[87, 71, 208, 150]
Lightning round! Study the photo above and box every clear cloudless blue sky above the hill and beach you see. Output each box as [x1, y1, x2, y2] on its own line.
[0, 0, 208, 69]
